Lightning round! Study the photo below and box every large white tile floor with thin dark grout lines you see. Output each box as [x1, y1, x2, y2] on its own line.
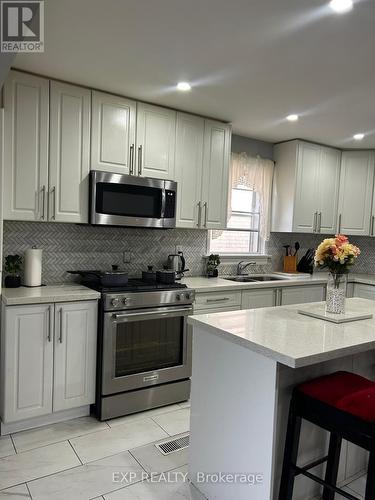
[0, 403, 365, 500]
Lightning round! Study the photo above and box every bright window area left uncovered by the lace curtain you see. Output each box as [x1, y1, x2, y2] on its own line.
[210, 185, 264, 254]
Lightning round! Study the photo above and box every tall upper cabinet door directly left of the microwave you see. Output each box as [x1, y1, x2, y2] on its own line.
[48, 81, 91, 223]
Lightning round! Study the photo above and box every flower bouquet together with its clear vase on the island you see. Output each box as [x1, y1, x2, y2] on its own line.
[314, 234, 361, 314]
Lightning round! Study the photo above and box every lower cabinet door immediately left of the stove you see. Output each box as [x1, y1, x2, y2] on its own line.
[53, 301, 97, 411]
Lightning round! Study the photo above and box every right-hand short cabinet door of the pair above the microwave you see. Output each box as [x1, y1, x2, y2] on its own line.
[135, 103, 176, 180]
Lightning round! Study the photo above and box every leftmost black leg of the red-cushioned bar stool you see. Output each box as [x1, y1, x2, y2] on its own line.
[279, 403, 302, 500]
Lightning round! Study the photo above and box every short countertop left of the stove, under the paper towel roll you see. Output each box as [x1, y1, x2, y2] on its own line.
[1, 285, 100, 306]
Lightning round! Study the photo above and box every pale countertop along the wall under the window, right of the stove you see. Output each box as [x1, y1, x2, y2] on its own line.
[181, 273, 375, 293]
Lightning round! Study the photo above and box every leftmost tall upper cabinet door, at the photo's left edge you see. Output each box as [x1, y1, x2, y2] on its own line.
[4, 71, 49, 220]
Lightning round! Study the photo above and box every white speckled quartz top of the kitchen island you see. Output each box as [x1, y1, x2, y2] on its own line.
[188, 298, 375, 368]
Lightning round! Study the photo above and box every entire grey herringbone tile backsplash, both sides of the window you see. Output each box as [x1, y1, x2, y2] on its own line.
[4, 221, 375, 284]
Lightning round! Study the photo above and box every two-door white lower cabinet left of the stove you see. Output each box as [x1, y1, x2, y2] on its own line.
[1, 301, 97, 424]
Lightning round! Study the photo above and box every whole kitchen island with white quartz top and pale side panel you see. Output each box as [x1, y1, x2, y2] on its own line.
[189, 298, 375, 500]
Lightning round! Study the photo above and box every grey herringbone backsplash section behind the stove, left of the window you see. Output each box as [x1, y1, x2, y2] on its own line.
[4, 221, 206, 284]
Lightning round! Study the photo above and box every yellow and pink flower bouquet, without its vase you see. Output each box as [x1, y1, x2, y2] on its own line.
[314, 234, 361, 274]
